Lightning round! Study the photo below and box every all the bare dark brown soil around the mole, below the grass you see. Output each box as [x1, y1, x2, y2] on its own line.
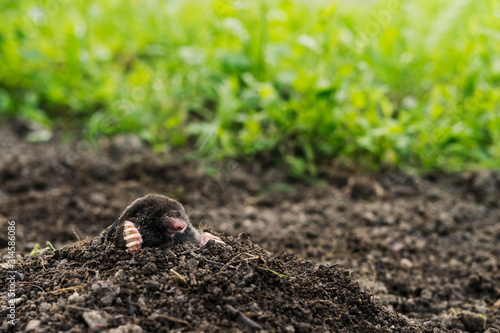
[0, 120, 500, 333]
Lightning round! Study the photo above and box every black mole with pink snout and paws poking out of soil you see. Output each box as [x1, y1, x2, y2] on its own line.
[105, 193, 225, 253]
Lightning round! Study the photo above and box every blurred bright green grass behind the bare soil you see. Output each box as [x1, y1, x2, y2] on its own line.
[0, 0, 500, 176]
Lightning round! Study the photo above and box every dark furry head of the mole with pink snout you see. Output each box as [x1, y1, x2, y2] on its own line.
[121, 194, 189, 236]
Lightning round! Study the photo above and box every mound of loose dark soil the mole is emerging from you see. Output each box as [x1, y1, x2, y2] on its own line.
[0, 235, 442, 332]
